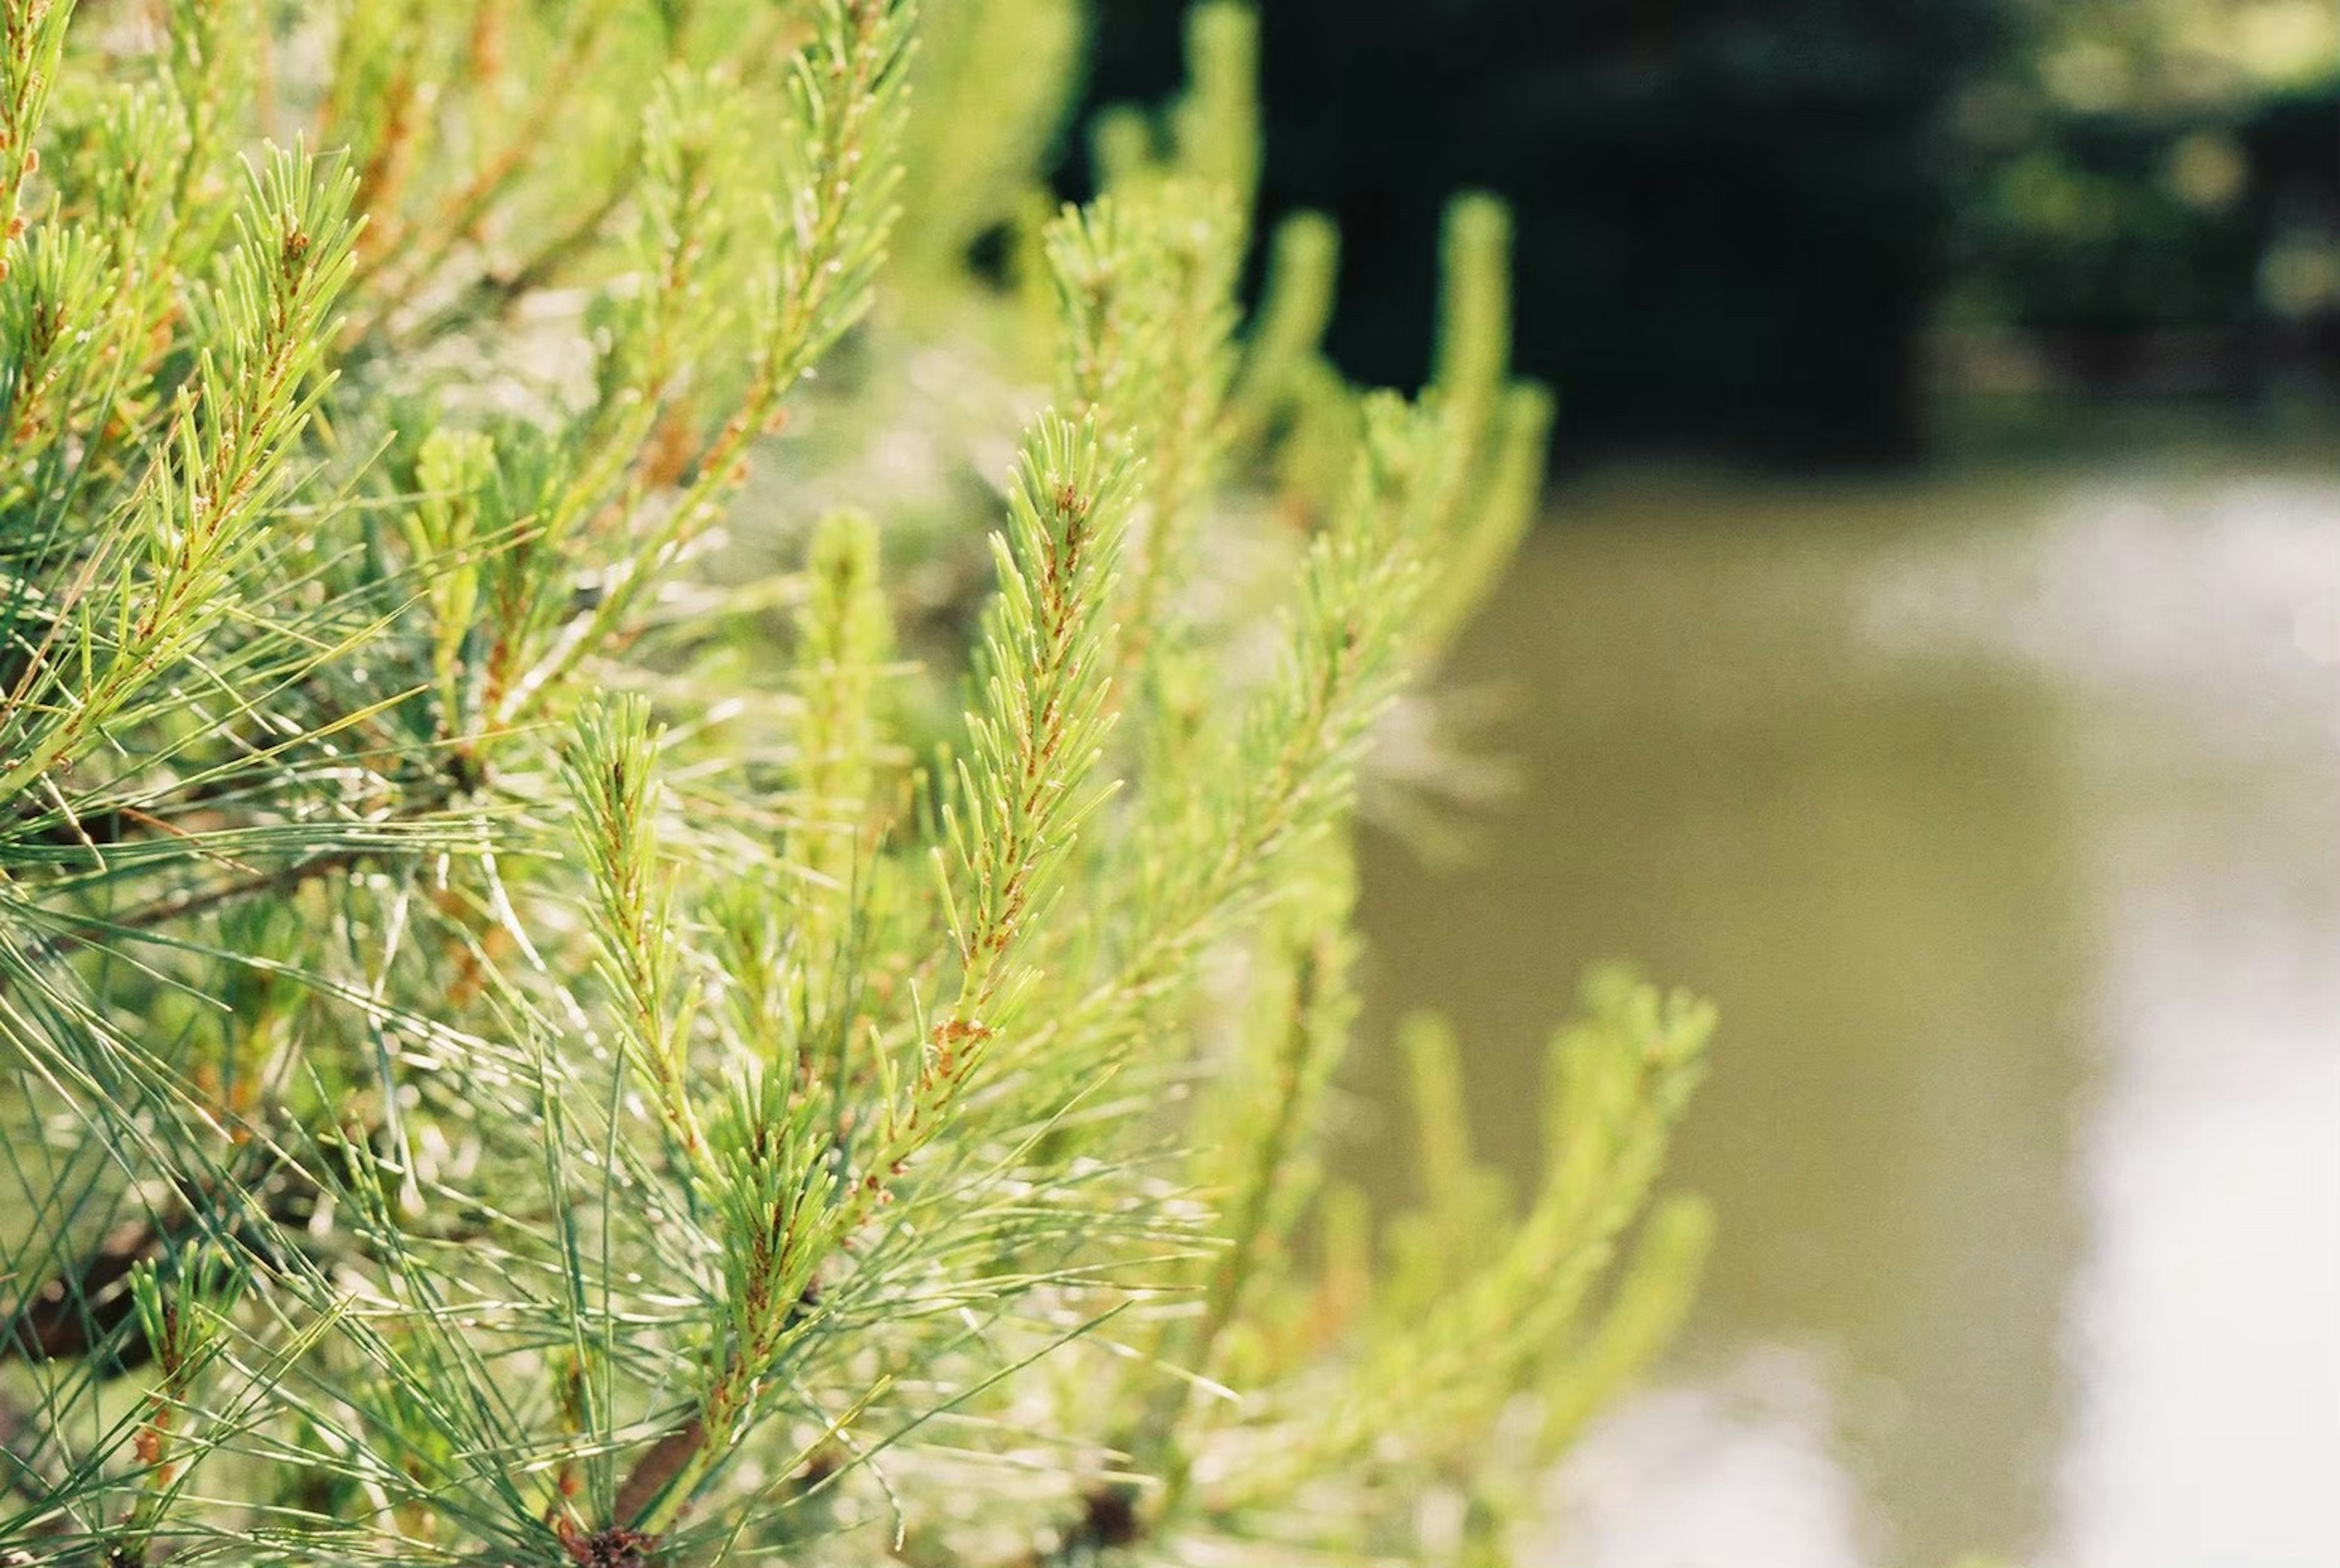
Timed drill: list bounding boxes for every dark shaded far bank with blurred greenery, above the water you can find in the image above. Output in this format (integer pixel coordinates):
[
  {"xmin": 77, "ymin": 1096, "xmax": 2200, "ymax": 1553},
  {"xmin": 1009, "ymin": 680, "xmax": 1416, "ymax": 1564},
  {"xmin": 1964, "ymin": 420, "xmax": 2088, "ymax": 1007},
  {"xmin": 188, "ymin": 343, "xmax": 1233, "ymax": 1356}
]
[{"xmin": 1062, "ymin": 0, "xmax": 2340, "ymax": 468}]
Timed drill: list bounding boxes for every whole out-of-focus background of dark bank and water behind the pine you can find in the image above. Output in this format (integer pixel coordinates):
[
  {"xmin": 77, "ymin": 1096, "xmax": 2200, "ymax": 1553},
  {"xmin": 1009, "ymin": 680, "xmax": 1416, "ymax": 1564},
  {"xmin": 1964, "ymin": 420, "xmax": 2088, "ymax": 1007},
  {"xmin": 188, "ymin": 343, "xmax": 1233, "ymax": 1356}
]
[{"xmin": 1060, "ymin": 0, "xmax": 2340, "ymax": 1568}]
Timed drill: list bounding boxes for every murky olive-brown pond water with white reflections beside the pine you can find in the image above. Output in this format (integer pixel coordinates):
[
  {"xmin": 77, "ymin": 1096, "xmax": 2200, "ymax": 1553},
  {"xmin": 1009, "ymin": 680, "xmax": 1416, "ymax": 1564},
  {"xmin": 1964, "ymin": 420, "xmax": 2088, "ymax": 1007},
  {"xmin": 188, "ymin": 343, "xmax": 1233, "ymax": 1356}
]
[{"xmin": 1357, "ymin": 452, "xmax": 2340, "ymax": 1568}]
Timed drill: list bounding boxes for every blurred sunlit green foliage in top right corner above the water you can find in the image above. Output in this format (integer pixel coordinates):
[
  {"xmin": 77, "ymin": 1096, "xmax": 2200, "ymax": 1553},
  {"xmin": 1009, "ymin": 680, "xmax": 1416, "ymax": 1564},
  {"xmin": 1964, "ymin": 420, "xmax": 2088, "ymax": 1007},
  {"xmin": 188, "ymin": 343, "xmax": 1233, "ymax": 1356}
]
[{"xmin": 1949, "ymin": 0, "xmax": 2340, "ymax": 363}]
